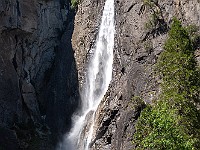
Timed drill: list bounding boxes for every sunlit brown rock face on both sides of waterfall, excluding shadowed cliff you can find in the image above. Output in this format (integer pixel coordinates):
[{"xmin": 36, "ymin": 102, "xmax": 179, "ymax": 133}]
[{"xmin": 72, "ymin": 0, "xmax": 200, "ymax": 150}]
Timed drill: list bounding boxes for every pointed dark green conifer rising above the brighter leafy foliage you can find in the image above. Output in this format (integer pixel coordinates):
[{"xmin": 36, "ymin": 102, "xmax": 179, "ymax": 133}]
[{"xmin": 157, "ymin": 19, "xmax": 200, "ymax": 100}]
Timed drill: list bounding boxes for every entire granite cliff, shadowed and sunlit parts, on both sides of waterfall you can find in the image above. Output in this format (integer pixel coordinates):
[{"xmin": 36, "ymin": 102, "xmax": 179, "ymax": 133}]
[{"xmin": 0, "ymin": 0, "xmax": 200, "ymax": 150}]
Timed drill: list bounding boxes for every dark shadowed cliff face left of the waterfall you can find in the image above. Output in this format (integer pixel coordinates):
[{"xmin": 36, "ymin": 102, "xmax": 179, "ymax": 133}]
[{"xmin": 0, "ymin": 0, "xmax": 79, "ymax": 150}]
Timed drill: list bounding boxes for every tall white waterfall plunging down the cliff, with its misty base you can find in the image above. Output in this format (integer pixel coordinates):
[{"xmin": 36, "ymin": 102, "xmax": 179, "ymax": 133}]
[{"xmin": 57, "ymin": 0, "xmax": 115, "ymax": 150}]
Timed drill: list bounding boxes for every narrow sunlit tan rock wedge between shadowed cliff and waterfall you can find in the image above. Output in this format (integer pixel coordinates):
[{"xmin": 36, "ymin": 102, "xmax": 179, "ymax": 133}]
[{"xmin": 72, "ymin": 0, "xmax": 105, "ymax": 87}]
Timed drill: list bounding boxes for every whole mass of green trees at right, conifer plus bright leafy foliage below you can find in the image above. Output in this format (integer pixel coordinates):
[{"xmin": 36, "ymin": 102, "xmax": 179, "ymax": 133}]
[{"xmin": 133, "ymin": 19, "xmax": 200, "ymax": 150}]
